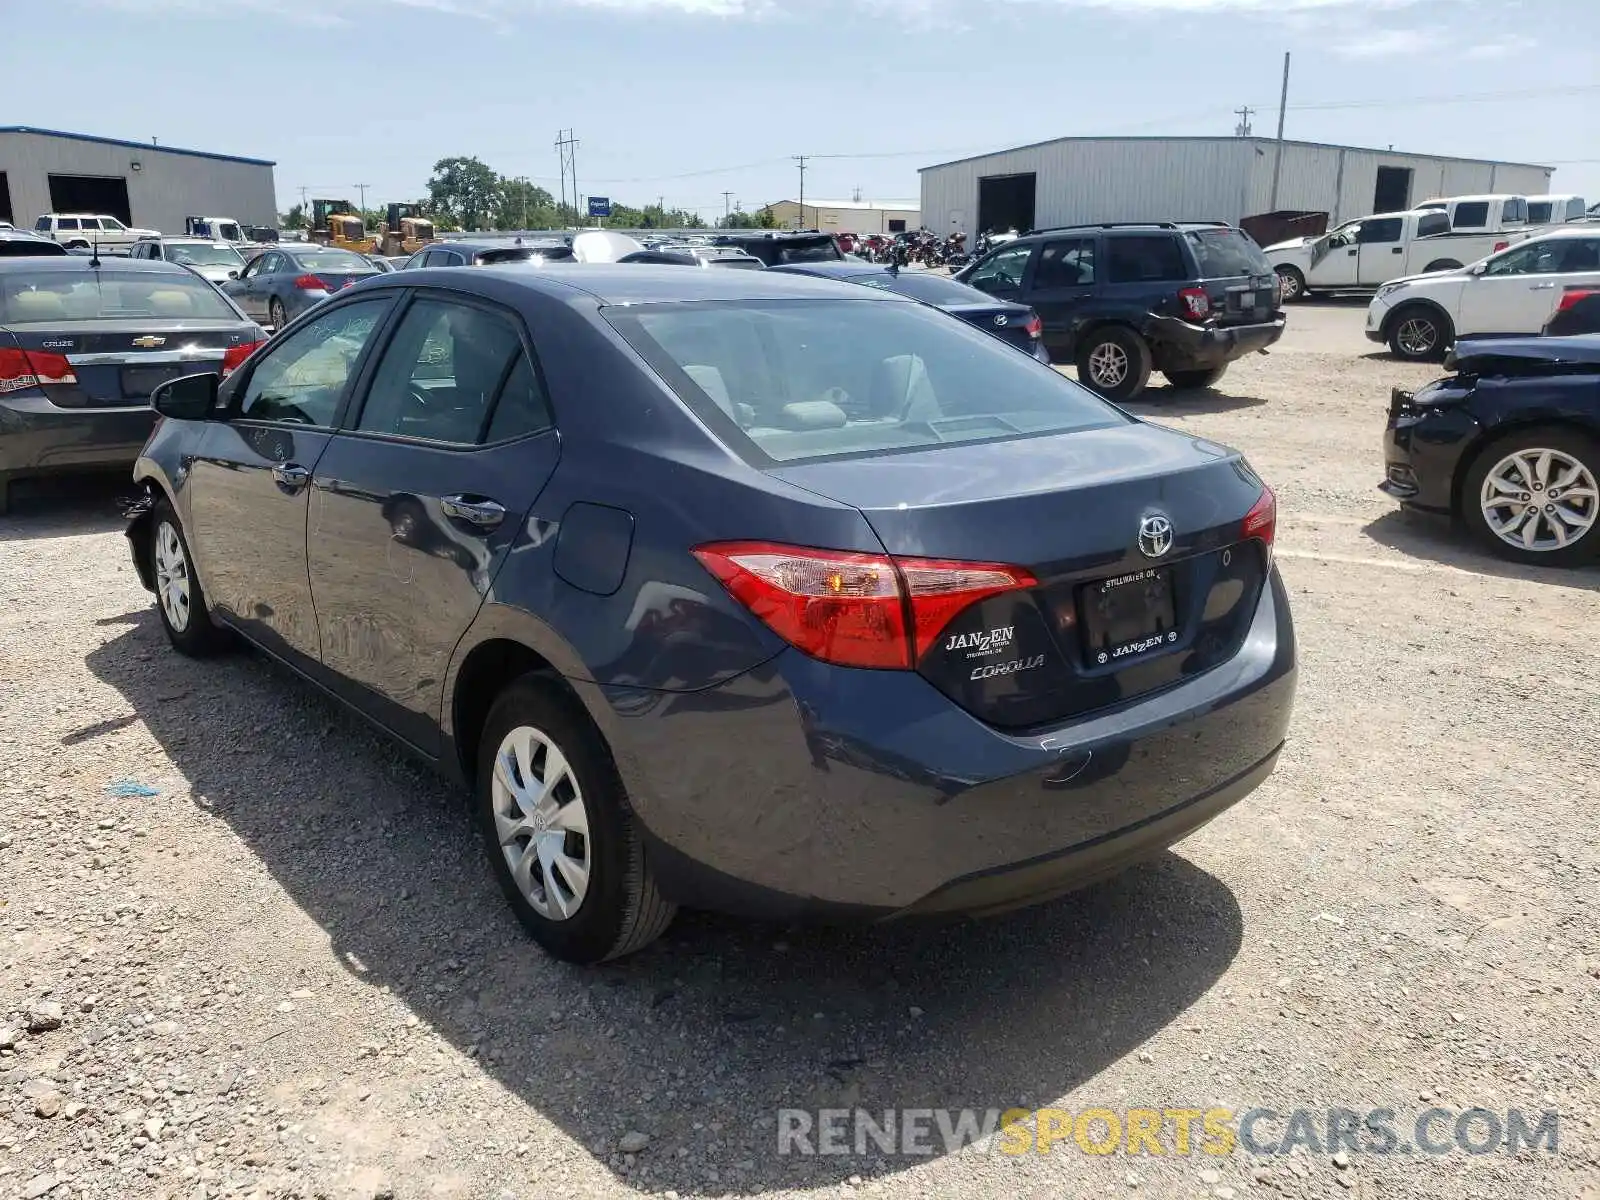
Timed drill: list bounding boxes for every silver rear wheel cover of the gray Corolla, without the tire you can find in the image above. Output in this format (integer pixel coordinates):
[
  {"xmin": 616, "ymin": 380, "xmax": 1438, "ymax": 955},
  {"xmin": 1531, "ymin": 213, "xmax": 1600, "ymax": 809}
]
[{"xmin": 491, "ymin": 725, "xmax": 590, "ymax": 922}]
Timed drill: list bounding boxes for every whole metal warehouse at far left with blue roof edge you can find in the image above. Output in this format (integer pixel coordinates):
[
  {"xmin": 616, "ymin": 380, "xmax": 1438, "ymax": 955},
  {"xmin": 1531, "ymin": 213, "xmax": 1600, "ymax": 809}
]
[{"xmin": 0, "ymin": 125, "xmax": 278, "ymax": 234}]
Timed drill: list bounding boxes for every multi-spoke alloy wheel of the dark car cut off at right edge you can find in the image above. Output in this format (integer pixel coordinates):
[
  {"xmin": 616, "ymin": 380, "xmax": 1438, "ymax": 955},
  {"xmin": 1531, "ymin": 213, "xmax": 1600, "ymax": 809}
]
[{"xmin": 1478, "ymin": 446, "xmax": 1600, "ymax": 552}]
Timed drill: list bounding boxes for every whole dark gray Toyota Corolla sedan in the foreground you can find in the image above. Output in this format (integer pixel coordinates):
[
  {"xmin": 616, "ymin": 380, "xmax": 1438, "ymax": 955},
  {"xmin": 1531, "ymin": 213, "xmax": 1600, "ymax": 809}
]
[{"xmin": 128, "ymin": 266, "xmax": 1296, "ymax": 962}]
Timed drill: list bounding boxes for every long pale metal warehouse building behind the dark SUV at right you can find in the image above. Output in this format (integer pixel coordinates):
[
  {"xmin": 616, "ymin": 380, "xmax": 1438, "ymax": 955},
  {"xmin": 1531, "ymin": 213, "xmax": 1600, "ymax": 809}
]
[{"xmin": 922, "ymin": 138, "xmax": 1555, "ymax": 241}]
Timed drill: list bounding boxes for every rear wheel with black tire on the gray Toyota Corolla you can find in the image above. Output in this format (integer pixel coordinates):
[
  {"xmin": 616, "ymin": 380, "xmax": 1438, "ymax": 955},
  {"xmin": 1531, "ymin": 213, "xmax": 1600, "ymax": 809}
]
[{"xmin": 474, "ymin": 674, "xmax": 677, "ymax": 965}]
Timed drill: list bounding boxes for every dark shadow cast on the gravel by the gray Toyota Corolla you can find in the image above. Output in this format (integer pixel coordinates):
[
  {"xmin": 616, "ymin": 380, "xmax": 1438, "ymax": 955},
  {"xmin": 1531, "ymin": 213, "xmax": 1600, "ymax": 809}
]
[{"xmin": 86, "ymin": 611, "xmax": 1242, "ymax": 1195}]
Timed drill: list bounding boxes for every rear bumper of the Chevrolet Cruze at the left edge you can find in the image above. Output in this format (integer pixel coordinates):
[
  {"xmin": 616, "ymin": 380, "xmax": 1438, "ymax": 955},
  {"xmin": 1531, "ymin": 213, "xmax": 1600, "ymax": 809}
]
[{"xmin": 0, "ymin": 389, "xmax": 155, "ymax": 478}]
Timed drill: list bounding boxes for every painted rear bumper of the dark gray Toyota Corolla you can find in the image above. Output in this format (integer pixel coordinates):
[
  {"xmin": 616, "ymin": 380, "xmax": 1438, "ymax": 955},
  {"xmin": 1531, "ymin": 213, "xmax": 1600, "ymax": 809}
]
[{"xmin": 603, "ymin": 571, "xmax": 1296, "ymax": 920}]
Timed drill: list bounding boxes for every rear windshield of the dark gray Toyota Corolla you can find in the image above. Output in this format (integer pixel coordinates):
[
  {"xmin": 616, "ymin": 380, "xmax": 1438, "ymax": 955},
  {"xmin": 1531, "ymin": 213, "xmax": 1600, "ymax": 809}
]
[{"xmin": 605, "ymin": 299, "xmax": 1128, "ymax": 466}]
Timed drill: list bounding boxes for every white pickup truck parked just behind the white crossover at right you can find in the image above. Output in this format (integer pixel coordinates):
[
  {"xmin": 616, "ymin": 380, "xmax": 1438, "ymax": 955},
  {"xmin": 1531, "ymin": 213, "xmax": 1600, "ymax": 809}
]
[{"xmin": 1267, "ymin": 210, "xmax": 1528, "ymax": 301}]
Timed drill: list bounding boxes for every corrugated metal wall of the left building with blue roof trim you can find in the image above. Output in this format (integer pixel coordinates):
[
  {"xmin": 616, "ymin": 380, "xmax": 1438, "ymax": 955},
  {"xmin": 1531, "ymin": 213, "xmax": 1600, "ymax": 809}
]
[{"xmin": 0, "ymin": 133, "xmax": 278, "ymax": 234}]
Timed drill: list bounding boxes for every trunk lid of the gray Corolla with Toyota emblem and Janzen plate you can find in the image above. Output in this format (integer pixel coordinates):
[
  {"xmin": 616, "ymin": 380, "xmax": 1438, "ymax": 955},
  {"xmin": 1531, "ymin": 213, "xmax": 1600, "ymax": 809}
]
[{"xmin": 771, "ymin": 424, "xmax": 1270, "ymax": 728}]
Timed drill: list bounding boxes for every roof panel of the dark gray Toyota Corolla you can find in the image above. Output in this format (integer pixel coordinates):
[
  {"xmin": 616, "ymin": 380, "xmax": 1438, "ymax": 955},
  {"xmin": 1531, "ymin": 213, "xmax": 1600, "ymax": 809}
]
[{"xmin": 406, "ymin": 262, "xmax": 915, "ymax": 304}]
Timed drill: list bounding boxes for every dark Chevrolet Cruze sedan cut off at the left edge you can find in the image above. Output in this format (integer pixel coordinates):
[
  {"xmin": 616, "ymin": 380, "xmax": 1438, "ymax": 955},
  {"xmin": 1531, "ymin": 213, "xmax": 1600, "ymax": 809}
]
[{"xmin": 0, "ymin": 254, "xmax": 266, "ymax": 512}]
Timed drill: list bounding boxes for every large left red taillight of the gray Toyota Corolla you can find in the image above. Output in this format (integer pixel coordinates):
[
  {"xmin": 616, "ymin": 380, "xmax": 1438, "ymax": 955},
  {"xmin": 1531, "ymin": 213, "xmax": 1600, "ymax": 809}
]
[{"xmin": 694, "ymin": 542, "xmax": 1037, "ymax": 670}]
